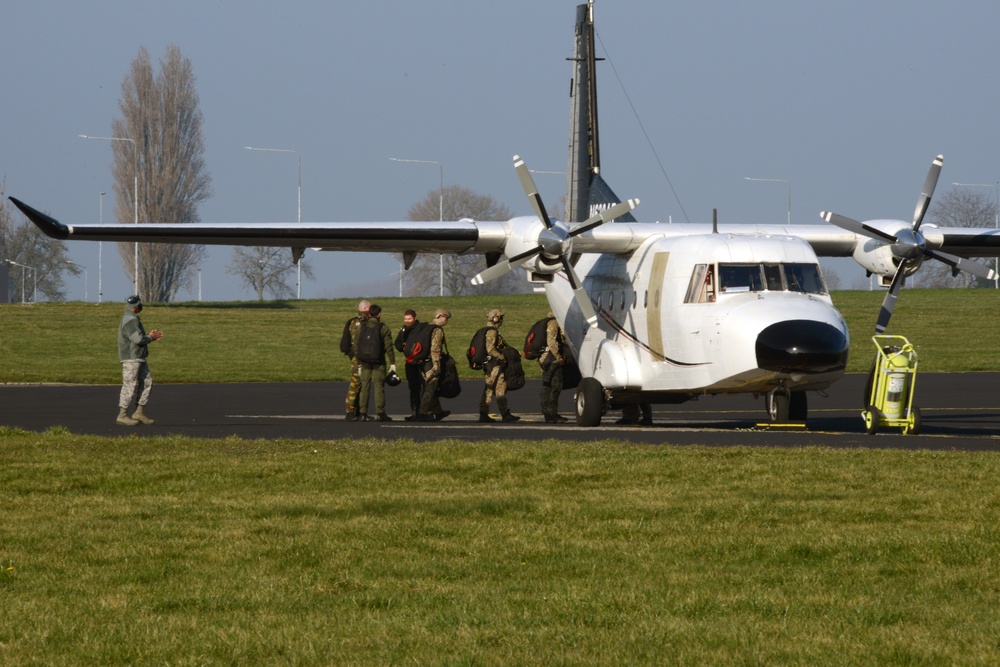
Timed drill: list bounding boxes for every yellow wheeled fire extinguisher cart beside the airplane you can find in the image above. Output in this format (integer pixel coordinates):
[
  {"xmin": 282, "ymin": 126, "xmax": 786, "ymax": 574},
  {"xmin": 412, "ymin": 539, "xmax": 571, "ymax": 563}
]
[{"xmin": 861, "ymin": 335, "xmax": 920, "ymax": 435}]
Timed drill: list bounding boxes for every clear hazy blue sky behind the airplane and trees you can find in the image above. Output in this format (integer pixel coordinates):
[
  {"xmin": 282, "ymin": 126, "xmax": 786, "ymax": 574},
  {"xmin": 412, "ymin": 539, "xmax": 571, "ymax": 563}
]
[{"xmin": 0, "ymin": 0, "xmax": 1000, "ymax": 301}]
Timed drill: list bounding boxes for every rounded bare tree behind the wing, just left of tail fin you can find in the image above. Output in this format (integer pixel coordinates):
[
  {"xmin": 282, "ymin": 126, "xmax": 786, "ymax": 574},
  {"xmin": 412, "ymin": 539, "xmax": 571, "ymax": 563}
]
[{"xmin": 404, "ymin": 185, "xmax": 530, "ymax": 296}]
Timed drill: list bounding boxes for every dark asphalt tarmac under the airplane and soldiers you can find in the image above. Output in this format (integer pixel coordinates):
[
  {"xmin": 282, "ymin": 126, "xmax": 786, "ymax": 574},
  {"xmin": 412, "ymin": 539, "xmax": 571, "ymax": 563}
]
[{"xmin": 0, "ymin": 374, "xmax": 1000, "ymax": 451}]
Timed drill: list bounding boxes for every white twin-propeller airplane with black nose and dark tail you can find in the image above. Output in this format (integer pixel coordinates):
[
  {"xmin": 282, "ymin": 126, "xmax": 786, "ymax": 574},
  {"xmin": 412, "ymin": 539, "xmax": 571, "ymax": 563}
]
[{"xmin": 10, "ymin": 0, "xmax": 1000, "ymax": 426}]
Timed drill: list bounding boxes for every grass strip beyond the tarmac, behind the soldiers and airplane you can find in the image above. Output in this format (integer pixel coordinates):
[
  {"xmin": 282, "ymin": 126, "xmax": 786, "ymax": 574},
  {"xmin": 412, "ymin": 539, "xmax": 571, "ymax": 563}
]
[{"xmin": 0, "ymin": 289, "xmax": 1000, "ymax": 384}]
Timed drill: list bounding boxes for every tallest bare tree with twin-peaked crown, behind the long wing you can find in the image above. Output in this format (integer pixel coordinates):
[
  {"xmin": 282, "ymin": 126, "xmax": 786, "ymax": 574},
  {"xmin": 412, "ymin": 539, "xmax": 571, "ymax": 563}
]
[{"xmin": 111, "ymin": 46, "xmax": 212, "ymax": 302}]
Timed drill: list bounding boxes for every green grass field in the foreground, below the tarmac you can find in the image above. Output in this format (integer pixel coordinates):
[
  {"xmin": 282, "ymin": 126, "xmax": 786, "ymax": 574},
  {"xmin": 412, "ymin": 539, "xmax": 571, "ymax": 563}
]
[{"xmin": 0, "ymin": 429, "xmax": 1000, "ymax": 665}]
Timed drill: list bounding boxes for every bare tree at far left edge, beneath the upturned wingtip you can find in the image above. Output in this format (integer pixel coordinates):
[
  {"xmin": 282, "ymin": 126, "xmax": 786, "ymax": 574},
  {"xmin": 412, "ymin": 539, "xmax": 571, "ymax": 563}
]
[{"xmin": 0, "ymin": 180, "xmax": 81, "ymax": 301}]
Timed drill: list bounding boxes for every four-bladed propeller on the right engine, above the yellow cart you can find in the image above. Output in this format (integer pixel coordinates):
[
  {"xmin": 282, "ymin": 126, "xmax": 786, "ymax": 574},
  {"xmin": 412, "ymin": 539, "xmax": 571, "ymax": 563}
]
[{"xmin": 820, "ymin": 155, "xmax": 996, "ymax": 334}]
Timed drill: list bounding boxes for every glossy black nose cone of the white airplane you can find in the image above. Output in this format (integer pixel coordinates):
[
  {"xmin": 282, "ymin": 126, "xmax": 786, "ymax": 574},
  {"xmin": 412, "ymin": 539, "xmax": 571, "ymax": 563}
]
[{"xmin": 757, "ymin": 320, "xmax": 848, "ymax": 373}]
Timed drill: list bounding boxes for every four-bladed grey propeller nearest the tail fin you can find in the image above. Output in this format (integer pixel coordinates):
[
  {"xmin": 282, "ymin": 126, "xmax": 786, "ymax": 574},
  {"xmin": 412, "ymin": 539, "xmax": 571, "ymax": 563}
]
[{"xmin": 472, "ymin": 155, "xmax": 639, "ymax": 327}]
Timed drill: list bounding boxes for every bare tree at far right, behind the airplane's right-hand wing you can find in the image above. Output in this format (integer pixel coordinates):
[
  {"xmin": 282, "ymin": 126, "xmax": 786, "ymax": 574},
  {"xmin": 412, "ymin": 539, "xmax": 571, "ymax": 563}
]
[{"xmin": 909, "ymin": 188, "xmax": 997, "ymax": 287}]
